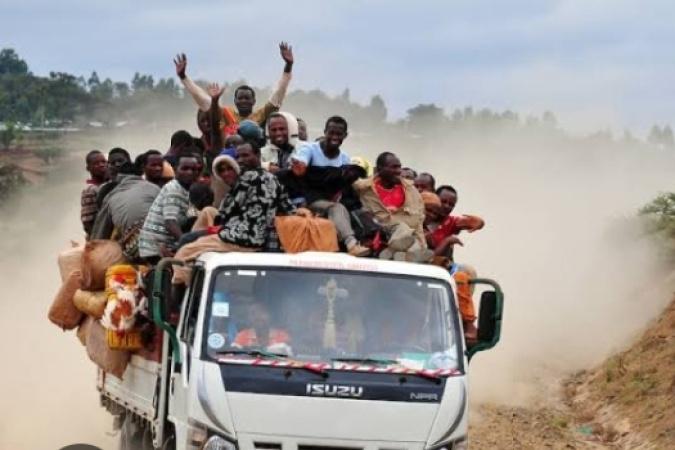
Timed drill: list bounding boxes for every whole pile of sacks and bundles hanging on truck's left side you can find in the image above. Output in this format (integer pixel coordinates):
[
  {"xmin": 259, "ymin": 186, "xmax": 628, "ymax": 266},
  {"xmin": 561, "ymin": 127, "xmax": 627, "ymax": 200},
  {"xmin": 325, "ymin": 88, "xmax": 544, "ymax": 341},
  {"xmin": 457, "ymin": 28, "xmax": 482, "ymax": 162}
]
[{"xmin": 48, "ymin": 240, "xmax": 152, "ymax": 378}]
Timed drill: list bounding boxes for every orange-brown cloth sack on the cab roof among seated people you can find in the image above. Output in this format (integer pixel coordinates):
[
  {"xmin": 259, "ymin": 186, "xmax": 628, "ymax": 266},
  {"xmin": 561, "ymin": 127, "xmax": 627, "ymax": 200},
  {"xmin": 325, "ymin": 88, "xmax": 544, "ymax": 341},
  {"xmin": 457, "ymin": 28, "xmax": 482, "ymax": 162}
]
[{"xmin": 274, "ymin": 216, "xmax": 339, "ymax": 253}]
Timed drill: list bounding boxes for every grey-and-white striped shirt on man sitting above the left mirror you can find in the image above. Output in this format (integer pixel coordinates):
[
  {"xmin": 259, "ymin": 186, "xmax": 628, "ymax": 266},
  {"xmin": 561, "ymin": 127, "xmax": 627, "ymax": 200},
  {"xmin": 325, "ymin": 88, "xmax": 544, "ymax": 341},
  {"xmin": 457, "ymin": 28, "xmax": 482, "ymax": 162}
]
[{"xmin": 139, "ymin": 180, "xmax": 190, "ymax": 258}]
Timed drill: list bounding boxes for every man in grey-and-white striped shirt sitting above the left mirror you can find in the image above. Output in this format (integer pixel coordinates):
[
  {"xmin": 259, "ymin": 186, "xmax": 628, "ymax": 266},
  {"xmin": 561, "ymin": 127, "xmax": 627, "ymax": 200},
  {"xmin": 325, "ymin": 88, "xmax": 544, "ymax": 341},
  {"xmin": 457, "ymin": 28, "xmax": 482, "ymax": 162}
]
[{"xmin": 139, "ymin": 151, "xmax": 199, "ymax": 264}]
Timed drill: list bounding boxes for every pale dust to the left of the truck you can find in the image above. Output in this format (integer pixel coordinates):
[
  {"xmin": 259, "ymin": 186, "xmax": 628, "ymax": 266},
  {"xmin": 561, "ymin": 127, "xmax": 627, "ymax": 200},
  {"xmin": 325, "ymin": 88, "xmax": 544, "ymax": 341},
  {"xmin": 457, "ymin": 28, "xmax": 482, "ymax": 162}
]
[{"xmin": 0, "ymin": 128, "xmax": 176, "ymax": 450}]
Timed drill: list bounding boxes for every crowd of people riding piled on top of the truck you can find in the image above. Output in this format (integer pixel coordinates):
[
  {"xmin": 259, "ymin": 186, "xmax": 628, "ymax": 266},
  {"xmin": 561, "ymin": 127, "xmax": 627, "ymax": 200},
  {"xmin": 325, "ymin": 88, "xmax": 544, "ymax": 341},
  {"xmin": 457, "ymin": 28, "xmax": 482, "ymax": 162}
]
[{"xmin": 81, "ymin": 43, "xmax": 484, "ymax": 338}]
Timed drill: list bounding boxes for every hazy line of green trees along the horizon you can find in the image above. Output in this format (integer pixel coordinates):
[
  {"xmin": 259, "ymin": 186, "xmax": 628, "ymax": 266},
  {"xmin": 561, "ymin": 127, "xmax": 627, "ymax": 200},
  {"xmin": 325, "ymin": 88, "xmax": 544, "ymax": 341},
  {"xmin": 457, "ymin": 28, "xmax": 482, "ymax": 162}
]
[{"xmin": 0, "ymin": 48, "xmax": 675, "ymax": 149}]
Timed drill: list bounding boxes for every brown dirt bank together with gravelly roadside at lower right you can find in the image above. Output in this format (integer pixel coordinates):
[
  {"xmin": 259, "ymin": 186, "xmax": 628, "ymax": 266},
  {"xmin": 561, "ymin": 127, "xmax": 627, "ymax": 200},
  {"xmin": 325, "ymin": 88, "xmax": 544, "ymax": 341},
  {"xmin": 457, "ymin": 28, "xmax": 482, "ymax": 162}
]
[{"xmin": 469, "ymin": 300, "xmax": 675, "ymax": 450}]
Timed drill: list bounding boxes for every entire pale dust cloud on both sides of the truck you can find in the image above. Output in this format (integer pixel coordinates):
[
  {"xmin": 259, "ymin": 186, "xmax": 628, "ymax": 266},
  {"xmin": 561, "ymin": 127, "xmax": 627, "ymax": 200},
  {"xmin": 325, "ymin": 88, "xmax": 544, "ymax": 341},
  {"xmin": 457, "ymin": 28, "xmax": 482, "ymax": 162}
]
[{"xmin": 0, "ymin": 112, "xmax": 675, "ymax": 450}]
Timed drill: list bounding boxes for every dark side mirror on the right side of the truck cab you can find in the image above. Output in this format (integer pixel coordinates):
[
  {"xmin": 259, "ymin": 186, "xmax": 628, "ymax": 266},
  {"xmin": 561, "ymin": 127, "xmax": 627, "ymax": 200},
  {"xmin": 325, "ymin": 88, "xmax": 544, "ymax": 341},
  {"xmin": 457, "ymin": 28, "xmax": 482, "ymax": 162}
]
[{"xmin": 466, "ymin": 278, "xmax": 504, "ymax": 360}]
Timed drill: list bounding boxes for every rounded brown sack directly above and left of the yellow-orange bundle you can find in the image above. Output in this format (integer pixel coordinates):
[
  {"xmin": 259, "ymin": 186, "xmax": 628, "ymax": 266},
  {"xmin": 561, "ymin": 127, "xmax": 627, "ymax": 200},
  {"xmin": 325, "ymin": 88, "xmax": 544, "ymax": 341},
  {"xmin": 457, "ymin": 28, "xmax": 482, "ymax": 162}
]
[{"xmin": 80, "ymin": 240, "xmax": 124, "ymax": 291}]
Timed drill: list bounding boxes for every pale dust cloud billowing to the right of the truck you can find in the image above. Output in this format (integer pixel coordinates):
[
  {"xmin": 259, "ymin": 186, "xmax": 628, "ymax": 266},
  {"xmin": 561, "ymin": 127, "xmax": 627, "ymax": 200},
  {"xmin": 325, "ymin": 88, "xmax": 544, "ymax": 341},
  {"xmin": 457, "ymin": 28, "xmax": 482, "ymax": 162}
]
[{"xmin": 400, "ymin": 133, "xmax": 675, "ymax": 404}]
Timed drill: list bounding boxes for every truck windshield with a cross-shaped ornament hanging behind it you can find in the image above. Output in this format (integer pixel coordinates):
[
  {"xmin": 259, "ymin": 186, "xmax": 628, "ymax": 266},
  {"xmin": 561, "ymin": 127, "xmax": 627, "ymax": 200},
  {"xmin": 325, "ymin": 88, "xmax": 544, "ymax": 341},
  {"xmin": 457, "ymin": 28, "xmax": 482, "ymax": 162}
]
[{"xmin": 205, "ymin": 268, "xmax": 459, "ymax": 370}]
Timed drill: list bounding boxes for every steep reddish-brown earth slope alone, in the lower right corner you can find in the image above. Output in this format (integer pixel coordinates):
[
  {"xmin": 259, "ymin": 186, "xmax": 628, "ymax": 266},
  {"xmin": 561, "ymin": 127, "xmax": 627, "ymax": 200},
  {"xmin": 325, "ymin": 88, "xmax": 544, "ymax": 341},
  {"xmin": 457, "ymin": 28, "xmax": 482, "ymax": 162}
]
[{"xmin": 568, "ymin": 301, "xmax": 675, "ymax": 449}]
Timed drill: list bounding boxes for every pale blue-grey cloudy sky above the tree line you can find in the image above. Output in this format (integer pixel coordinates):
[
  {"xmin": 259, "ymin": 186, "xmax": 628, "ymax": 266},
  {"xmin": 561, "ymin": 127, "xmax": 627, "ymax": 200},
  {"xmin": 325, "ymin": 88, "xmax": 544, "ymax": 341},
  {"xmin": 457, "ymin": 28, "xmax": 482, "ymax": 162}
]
[{"xmin": 0, "ymin": 0, "xmax": 675, "ymax": 134}]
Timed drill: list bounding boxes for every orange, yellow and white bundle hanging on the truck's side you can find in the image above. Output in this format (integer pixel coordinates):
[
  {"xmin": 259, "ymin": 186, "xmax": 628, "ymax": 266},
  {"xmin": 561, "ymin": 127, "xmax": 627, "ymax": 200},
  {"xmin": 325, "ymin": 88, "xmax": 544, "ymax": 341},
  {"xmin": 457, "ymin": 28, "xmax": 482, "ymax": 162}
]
[{"xmin": 101, "ymin": 264, "xmax": 147, "ymax": 350}]
